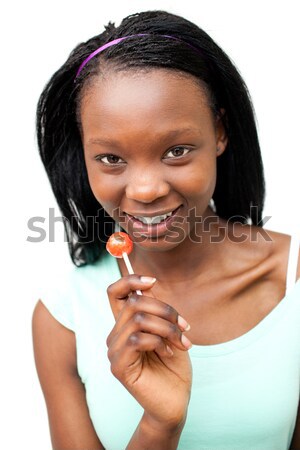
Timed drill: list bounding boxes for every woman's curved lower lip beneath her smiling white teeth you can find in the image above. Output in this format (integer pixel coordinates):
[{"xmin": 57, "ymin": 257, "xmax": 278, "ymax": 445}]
[{"xmin": 125, "ymin": 206, "xmax": 180, "ymax": 237}]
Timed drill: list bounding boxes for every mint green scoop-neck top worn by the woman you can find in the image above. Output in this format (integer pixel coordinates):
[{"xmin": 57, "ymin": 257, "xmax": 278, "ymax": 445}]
[{"xmin": 41, "ymin": 234, "xmax": 300, "ymax": 450}]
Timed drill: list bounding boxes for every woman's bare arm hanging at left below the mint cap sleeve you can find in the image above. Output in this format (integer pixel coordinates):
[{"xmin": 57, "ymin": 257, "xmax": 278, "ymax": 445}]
[{"xmin": 32, "ymin": 301, "xmax": 104, "ymax": 450}]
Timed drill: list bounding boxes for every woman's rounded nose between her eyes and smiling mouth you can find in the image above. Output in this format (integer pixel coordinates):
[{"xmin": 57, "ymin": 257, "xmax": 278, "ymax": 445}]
[{"xmin": 126, "ymin": 171, "xmax": 170, "ymax": 203}]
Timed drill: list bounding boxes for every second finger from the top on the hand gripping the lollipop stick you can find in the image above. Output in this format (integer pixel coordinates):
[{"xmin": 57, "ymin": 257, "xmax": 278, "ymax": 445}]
[{"xmin": 106, "ymin": 294, "xmax": 186, "ymax": 346}]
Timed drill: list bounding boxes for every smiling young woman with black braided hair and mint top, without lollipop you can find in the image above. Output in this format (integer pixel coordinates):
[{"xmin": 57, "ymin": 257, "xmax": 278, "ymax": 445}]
[{"xmin": 33, "ymin": 11, "xmax": 300, "ymax": 450}]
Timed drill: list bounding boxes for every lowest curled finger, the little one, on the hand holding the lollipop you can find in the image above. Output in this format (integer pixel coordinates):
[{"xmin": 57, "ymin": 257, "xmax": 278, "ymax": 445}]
[{"xmin": 108, "ymin": 332, "xmax": 172, "ymax": 379}]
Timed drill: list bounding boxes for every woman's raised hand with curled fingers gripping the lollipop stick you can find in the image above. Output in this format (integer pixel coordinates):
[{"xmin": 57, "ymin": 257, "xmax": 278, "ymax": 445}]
[{"xmin": 106, "ymin": 275, "xmax": 192, "ymax": 428}]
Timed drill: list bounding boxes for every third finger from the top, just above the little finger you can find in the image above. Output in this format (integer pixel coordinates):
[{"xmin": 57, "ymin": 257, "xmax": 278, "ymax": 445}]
[{"xmin": 110, "ymin": 311, "xmax": 191, "ymax": 352}]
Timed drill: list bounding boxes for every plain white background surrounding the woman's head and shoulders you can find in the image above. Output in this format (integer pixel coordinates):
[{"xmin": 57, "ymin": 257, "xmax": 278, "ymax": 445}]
[{"xmin": 0, "ymin": 0, "xmax": 300, "ymax": 450}]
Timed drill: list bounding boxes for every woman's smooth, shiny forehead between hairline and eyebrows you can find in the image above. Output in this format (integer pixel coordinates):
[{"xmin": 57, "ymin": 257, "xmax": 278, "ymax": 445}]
[{"xmin": 80, "ymin": 70, "xmax": 211, "ymax": 134}]
